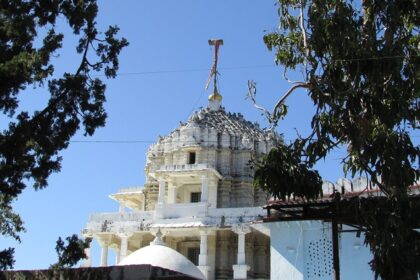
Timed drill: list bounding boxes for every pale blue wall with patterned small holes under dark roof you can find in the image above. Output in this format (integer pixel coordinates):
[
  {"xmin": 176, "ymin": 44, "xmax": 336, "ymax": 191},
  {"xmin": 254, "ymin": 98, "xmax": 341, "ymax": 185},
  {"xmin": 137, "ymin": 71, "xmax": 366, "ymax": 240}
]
[{"xmin": 264, "ymin": 221, "xmax": 373, "ymax": 280}]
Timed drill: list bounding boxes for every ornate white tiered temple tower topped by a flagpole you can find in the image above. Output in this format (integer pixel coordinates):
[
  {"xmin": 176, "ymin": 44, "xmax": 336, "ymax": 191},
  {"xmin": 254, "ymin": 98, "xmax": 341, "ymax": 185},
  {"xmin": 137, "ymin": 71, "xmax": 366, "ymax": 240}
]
[{"xmin": 83, "ymin": 40, "xmax": 279, "ymax": 279}]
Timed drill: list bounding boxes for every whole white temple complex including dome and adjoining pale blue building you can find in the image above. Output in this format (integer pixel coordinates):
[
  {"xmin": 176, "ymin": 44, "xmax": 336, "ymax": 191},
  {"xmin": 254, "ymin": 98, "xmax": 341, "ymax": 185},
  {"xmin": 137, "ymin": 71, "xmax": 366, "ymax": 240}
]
[{"xmin": 82, "ymin": 40, "xmax": 388, "ymax": 280}]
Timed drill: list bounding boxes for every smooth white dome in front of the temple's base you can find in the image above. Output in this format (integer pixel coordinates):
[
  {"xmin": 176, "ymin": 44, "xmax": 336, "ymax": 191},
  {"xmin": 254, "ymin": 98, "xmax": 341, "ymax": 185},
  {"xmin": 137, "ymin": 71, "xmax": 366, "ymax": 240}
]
[{"xmin": 118, "ymin": 244, "xmax": 205, "ymax": 279}]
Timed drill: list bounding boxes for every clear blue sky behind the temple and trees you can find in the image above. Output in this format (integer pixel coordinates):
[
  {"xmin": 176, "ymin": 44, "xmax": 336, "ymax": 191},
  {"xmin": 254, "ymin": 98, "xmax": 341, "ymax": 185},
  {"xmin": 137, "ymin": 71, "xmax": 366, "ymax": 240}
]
[{"xmin": 0, "ymin": 0, "xmax": 352, "ymax": 269}]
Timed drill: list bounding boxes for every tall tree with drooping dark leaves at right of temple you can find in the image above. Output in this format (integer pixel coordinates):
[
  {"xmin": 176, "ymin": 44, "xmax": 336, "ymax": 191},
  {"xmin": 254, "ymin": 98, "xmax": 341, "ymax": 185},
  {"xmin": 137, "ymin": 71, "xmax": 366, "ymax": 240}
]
[{"xmin": 249, "ymin": 0, "xmax": 420, "ymax": 279}]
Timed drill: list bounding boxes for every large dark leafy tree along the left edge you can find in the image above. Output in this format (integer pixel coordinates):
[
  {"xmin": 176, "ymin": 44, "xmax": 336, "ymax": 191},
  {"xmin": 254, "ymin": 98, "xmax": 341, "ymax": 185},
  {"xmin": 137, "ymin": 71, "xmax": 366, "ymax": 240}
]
[{"xmin": 0, "ymin": 0, "xmax": 128, "ymax": 267}]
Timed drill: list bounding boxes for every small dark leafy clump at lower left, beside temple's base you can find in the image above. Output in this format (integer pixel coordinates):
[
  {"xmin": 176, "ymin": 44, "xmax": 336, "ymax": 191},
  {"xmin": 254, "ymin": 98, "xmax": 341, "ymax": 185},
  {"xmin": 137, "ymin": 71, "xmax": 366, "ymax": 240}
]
[{"xmin": 51, "ymin": 234, "xmax": 92, "ymax": 269}]
